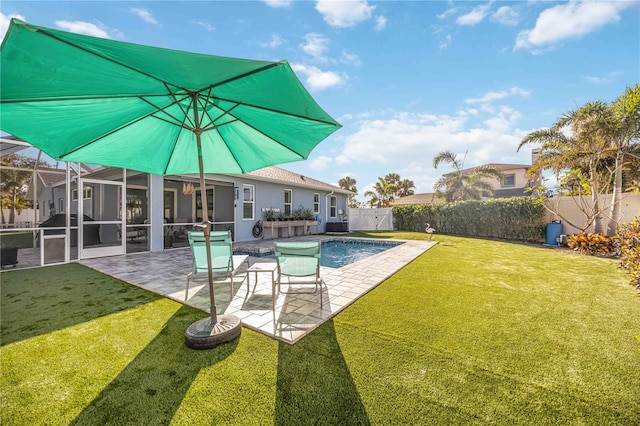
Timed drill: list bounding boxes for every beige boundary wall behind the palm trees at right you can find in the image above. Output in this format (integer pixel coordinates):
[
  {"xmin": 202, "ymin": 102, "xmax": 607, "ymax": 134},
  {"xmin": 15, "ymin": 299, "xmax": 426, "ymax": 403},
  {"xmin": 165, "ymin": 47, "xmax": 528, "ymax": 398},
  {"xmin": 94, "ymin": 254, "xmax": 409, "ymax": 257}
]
[{"xmin": 546, "ymin": 192, "xmax": 640, "ymax": 235}]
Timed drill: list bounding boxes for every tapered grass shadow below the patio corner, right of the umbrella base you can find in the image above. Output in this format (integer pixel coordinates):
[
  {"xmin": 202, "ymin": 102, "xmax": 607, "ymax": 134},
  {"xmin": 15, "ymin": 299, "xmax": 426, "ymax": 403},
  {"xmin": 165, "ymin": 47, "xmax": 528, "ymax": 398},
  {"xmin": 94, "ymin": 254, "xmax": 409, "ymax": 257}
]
[{"xmin": 274, "ymin": 320, "xmax": 370, "ymax": 425}]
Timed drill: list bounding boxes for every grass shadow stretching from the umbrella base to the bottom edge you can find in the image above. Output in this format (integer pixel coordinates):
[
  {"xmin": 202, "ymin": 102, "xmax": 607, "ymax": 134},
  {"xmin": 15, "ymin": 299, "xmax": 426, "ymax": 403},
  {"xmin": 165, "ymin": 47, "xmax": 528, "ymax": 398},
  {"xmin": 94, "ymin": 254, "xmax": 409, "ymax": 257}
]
[{"xmin": 71, "ymin": 306, "xmax": 239, "ymax": 425}]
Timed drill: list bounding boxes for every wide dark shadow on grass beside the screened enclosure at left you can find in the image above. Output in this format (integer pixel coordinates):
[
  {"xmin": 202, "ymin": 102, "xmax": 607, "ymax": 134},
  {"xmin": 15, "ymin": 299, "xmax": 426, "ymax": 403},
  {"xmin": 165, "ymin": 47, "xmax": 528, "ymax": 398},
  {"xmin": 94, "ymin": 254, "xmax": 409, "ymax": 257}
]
[{"xmin": 0, "ymin": 263, "xmax": 161, "ymax": 346}]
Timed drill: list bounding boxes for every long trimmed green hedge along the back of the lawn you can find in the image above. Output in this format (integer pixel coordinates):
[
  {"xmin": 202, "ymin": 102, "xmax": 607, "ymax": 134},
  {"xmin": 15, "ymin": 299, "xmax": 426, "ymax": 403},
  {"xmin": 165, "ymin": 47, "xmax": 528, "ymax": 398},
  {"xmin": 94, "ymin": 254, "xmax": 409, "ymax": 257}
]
[{"xmin": 393, "ymin": 197, "xmax": 545, "ymax": 242}]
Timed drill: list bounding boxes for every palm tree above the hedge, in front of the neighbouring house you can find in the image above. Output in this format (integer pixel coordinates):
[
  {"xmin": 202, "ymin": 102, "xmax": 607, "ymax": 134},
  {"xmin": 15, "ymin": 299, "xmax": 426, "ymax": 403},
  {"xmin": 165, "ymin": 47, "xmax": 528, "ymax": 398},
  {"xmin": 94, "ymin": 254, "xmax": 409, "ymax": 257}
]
[{"xmin": 433, "ymin": 151, "xmax": 502, "ymax": 202}]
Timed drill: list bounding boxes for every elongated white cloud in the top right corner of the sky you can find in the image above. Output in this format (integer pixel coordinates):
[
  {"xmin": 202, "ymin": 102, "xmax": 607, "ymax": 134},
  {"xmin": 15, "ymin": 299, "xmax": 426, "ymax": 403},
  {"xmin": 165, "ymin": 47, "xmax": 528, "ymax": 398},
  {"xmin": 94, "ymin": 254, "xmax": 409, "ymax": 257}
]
[{"xmin": 514, "ymin": 1, "xmax": 637, "ymax": 49}]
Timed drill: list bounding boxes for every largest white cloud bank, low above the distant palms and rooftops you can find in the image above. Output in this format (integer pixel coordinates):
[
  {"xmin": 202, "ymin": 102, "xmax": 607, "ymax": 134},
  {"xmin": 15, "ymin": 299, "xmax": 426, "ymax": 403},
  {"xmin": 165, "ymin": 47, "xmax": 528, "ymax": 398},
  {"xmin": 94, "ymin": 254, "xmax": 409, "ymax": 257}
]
[{"xmin": 335, "ymin": 106, "xmax": 530, "ymax": 195}]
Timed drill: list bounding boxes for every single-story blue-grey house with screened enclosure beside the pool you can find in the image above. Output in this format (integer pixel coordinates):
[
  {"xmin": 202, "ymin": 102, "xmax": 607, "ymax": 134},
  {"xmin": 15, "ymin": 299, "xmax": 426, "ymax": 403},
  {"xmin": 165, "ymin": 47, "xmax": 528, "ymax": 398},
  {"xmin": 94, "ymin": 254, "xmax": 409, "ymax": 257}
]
[{"xmin": 30, "ymin": 165, "xmax": 352, "ymax": 258}]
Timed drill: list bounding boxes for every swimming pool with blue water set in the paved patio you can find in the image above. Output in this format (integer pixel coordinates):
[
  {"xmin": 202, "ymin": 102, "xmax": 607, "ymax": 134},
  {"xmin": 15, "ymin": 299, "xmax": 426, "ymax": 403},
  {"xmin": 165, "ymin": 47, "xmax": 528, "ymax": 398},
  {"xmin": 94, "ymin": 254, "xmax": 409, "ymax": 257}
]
[{"xmin": 236, "ymin": 239, "xmax": 402, "ymax": 268}]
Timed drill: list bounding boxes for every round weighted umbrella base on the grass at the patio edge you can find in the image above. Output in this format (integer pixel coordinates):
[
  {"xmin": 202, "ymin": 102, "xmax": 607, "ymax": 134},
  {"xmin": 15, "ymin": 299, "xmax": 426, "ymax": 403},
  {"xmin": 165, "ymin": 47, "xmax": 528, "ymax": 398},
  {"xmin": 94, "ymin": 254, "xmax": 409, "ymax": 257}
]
[{"xmin": 184, "ymin": 315, "xmax": 242, "ymax": 349}]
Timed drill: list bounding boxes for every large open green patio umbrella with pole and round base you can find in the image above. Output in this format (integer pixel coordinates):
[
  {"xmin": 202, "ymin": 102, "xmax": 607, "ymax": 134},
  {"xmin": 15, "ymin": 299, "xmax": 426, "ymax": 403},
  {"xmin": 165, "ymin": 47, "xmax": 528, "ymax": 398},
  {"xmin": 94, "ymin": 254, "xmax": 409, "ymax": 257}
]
[{"xmin": 0, "ymin": 19, "xmax": 340, "ymax": 347}]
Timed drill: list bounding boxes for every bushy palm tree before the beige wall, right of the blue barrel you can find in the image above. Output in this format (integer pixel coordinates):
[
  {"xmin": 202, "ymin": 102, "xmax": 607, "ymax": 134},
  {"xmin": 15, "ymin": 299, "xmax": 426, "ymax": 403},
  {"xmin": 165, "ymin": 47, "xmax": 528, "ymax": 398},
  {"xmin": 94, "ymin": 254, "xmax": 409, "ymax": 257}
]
[{"xmin": 518, "ymin": 101, "xmax": 611, "ymax": 233}]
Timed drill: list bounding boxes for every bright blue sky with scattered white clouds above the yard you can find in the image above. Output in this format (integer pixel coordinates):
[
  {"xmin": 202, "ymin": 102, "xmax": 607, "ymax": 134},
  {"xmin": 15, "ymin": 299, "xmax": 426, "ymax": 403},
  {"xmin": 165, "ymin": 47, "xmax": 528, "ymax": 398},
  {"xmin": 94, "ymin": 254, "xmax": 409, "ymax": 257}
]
[{"xmin": 0, "ymin": 0, "xmax": 640, "ymax": 200}]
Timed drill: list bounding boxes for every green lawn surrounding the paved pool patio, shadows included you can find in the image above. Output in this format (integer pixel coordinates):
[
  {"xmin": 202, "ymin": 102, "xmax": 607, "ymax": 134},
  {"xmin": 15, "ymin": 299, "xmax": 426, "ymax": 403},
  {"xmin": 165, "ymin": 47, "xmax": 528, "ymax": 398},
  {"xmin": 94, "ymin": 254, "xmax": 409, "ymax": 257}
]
[{"xmin": 0, "ymin": 232, "xmax": 640, "ymax": 425}]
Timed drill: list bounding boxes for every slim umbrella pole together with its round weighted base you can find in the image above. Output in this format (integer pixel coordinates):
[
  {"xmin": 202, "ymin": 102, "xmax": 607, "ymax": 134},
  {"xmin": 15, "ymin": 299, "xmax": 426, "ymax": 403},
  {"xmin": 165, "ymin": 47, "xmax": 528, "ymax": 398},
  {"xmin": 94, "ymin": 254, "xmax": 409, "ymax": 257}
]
[{"xmin": 185, "ymin": 93, "xmax": 242, "ymax": 349}]
